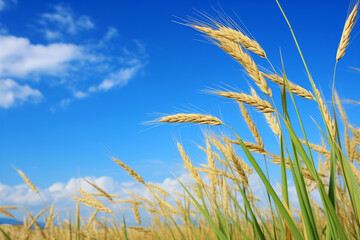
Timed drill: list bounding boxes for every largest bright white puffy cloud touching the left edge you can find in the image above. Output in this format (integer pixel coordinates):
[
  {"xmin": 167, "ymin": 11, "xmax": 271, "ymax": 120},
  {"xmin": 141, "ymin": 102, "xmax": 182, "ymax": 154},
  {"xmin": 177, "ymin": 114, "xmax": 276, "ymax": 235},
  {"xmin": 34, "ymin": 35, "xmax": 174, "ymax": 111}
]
[{"xmin": 0, "ymin": 36, "xmax": 83, "ymax": 77}]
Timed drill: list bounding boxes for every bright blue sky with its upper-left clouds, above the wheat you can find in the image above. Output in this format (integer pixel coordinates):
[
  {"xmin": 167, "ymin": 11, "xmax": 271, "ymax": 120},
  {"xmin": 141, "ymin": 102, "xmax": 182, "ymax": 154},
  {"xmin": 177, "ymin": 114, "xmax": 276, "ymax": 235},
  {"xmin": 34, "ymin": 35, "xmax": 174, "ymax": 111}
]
[{"xmin": 0, "ymin": 0, "xmax": 360, "ymax": 219}]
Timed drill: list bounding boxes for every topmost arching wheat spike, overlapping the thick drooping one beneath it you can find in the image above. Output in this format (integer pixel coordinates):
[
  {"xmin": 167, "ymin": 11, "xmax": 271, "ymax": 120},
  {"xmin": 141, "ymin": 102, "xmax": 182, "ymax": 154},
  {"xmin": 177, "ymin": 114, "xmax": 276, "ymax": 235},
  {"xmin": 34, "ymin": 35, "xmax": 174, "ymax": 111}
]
[{"xmin": 192, "ymin": 25, "xmax": 266, "ymax": 58}]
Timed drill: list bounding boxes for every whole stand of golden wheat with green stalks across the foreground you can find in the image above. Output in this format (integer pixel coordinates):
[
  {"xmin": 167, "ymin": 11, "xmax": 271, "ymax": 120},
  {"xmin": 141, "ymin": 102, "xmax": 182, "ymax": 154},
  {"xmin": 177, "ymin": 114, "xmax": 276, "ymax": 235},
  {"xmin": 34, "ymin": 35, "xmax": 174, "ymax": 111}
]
[{"xmin": 0, "ymin": 2, "xmax": 360, "ymax": 239}]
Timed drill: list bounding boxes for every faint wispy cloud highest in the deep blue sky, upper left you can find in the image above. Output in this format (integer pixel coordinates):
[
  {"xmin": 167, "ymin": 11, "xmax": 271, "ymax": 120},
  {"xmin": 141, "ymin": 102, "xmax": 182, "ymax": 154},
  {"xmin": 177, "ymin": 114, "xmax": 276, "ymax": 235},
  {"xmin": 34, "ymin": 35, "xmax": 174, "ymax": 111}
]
[{"xmin": 40, "ymin": 4, "xmax": 95, "ymax": 40}]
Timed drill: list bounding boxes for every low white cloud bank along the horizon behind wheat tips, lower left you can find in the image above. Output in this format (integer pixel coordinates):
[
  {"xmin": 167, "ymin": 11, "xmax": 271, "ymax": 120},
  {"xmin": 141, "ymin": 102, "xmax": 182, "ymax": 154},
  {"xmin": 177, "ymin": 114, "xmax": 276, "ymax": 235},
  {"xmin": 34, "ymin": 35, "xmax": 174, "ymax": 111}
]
[{"xmin": 0, "ymin": 175, "xmax": 192, "ymax": 221}]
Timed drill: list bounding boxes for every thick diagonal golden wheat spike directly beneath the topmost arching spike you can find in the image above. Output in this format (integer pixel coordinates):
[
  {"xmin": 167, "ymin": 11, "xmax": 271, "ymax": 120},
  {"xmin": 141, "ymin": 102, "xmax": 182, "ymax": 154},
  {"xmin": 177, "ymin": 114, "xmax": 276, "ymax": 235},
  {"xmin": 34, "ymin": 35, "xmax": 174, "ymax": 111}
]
[{"xmin": 217, "ymin": 38, "xmax": 272, "ymax": 96}]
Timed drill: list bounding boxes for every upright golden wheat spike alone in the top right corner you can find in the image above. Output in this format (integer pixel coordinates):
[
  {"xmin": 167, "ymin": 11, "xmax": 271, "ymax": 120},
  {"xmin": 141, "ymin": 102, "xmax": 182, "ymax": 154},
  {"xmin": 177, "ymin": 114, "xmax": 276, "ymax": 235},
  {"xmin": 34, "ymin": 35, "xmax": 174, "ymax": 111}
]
[{"xmin": 336, "ymin": 2, "xmax": 359, "ymax": 61}]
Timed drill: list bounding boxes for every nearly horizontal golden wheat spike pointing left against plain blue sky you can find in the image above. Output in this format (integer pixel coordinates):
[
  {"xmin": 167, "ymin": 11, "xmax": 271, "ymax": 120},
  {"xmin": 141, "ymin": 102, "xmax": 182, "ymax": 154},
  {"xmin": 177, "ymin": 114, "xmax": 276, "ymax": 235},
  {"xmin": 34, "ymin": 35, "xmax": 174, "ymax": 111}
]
[{"xmin": 159, "ymin": 113, "xmax": 223, "ymax": 125}]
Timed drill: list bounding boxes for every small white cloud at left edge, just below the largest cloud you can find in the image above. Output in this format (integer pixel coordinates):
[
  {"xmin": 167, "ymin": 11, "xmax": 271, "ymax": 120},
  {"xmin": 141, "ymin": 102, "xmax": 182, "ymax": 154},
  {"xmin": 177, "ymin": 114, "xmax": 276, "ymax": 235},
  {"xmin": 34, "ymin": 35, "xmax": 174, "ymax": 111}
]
[{"xmin": 0, "ymin": 79, "xmax": 42, "ymax": 109}]
